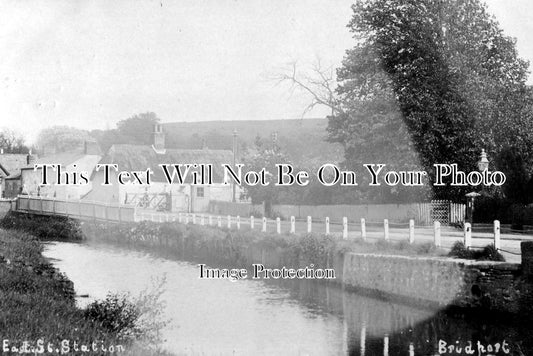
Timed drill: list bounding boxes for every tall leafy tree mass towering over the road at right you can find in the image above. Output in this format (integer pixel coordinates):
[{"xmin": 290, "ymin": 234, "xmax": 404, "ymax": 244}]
[{"xmin": 329, "ymin": 0, "xmax": 533, "ymax": 198}]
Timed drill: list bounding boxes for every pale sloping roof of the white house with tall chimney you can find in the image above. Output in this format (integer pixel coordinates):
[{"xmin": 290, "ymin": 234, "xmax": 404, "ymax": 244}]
[{"xmin": 100, "ymin": 144, "xmax": 233, "ymax": 182}]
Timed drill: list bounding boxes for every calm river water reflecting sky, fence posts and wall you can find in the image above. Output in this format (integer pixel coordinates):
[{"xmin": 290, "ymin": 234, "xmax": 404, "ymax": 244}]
[{"xmin": 45, "ymin": 242, "xmax": 533, "ymax": 356}]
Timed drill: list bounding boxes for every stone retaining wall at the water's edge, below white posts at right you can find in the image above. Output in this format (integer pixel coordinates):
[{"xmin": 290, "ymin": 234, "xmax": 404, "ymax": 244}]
[{"xmin": 343, "ymin": 253, "xmax": 522, "ymax": 312}]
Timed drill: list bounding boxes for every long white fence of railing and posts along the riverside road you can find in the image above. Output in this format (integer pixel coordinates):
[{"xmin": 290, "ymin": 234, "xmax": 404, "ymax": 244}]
[{"xmin": 15, "ymin": 195, "xmax": 490, "ymax": 252}]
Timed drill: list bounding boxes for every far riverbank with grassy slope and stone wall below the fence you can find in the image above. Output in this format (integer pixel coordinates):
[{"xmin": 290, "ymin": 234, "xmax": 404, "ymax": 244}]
[{"xmin": 6, "ymin": 214, "xmax": 533, "ymax": 315}]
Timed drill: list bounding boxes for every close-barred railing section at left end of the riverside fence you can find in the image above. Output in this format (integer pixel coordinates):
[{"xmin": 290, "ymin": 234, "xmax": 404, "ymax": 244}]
[{"xmin": 15, "ymin": 195, "xmax": 135, "ymax": 221}]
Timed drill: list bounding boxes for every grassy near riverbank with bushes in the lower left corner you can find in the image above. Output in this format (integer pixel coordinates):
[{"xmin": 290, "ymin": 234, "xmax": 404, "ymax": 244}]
[{"xmin": 0, "ymin": 229, "xmax": 170, "ymax": 355}]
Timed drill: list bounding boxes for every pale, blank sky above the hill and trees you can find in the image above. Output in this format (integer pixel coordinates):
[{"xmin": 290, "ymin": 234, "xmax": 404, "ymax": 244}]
[{"xmin": 0, "ymin": 0, "xmax": 533, "ymax": 143}]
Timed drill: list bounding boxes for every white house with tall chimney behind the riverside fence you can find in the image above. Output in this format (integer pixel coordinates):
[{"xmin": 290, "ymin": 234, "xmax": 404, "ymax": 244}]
[{"xmin": 86, "ymin": 124, "xmax": 233, "ymax": 212}]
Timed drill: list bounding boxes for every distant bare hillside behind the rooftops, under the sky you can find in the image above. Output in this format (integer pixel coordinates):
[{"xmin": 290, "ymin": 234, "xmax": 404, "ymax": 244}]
[{"xmin": 163, "ymin": 119, "xmax": 343, "ymax": 165}]
